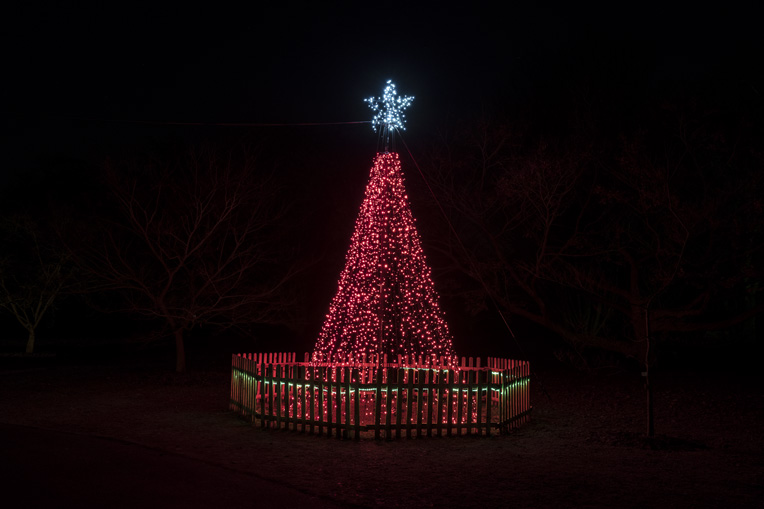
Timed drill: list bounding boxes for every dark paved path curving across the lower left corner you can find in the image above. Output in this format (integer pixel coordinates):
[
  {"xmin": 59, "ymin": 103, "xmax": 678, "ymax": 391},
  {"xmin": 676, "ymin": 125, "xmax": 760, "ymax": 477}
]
[{"xmin": 0, "ymin": 423, "xmax": 345, "ymax": 509}]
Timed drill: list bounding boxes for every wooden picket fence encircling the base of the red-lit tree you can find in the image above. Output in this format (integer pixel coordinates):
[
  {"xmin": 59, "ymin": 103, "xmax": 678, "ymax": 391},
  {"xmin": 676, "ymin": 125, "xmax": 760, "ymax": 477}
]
[{"xmin": 230, "ymin": 353, "xmax": 531, "ymax": 439}]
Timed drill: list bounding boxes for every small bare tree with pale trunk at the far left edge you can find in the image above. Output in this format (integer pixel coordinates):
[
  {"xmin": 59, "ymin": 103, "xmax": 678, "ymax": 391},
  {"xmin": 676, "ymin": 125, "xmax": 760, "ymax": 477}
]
[{"xmin": 0, "ymin": 215, "xmax": 73, "ymax": 354}]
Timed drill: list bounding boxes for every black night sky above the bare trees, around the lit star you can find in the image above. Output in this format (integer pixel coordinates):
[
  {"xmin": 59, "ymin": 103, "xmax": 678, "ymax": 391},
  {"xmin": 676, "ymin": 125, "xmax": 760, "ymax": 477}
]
[{"xmin": 0, "ymin": 2, "xmax": 764, "ymax": 354}]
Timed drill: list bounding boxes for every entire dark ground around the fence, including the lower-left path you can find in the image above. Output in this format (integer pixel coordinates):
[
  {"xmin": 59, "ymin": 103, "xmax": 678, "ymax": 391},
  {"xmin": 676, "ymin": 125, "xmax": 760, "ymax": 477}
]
[{"xmin": 0, "ymin": 350, "xmax": 764, "ymax": 508}]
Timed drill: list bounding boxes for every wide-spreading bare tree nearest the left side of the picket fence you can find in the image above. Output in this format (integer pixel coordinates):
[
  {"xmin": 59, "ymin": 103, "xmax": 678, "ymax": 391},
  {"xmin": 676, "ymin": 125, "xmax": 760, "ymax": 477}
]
[{"xmin": 79, "ymin": 146, "xmax": 295, "ymax": 372}]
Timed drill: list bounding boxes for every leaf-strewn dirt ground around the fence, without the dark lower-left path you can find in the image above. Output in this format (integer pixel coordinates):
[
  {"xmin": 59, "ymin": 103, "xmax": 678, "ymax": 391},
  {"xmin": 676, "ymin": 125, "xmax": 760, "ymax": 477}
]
[{"xmin": 0, "ymin": 366, "xmax": 764, "ymax": 507}]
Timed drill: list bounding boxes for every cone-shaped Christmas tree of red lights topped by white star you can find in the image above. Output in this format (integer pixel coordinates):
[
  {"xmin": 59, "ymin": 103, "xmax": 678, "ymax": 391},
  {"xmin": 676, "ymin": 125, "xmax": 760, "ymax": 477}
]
[{"xmin": 313, "ymin": 82, "xmax": 453, "ymax": 361}]
